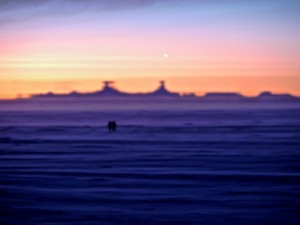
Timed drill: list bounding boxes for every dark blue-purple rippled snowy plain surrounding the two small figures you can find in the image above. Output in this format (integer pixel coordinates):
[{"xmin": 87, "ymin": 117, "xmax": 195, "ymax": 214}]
[{"xmin": 0, "ymin": 102, "xmax": 300, "ymax": 225}]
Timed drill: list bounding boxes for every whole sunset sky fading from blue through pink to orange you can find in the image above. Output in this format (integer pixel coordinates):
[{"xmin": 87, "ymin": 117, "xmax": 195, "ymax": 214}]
[{"xmin": 0, "ymin": 0, "xmax": 300, "ymax": 99}]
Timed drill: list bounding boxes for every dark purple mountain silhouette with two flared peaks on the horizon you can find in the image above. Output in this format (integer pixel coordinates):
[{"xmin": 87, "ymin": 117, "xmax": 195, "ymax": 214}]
[{"xmin": 31, "ymin": 81, "xmax": 300, "ymax": 101}]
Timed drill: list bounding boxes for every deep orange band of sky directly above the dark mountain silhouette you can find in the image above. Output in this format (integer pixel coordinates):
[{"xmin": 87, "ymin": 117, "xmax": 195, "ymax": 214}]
[{"xmin": 0, "ymin": 76, "xmax": 300, "ymax": 99}]
